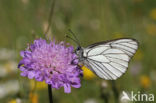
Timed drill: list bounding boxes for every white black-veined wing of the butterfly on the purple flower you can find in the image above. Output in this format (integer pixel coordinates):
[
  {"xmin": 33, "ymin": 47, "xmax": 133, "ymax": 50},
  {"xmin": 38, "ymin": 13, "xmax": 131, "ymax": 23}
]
[{"xmin": 83, "ymin": 38, "xmax": 138, "ymax": 80}]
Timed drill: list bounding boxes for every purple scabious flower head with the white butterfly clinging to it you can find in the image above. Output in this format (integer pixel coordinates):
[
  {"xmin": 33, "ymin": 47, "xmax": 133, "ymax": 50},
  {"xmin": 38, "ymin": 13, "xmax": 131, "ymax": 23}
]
[{"xmin": 18, "ymin": 39, "xmax": 82, "ymax": 93}]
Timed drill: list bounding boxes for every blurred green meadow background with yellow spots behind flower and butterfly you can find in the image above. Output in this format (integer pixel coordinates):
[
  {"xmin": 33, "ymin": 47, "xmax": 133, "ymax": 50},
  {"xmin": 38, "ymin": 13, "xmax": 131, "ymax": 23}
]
[{"xmin": 0, "ymin": 0, "xmax": 156, "ymax": 103}]
